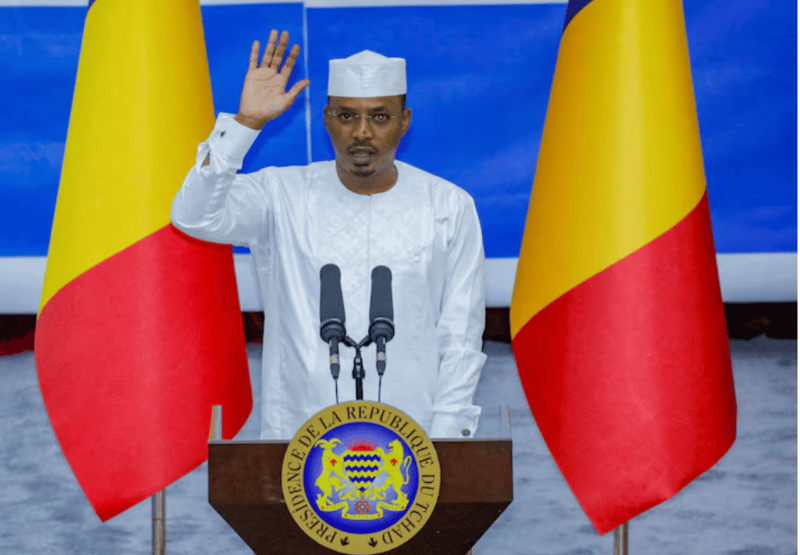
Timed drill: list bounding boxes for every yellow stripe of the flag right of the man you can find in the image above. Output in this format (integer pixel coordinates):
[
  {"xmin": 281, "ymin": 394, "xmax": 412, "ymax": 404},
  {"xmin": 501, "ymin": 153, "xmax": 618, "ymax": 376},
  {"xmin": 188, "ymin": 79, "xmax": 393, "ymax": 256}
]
[{"xmin": 511, "ymin": 0, "xmax": 705, "ymax": 336}]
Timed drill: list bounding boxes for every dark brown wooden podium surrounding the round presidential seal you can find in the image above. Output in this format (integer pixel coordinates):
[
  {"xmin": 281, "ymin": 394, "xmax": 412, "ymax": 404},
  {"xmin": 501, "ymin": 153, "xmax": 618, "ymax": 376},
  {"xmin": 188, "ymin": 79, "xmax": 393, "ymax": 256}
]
[{"xmin": 208, "ymin": 439, "xmax": 513, "ymax": 555}]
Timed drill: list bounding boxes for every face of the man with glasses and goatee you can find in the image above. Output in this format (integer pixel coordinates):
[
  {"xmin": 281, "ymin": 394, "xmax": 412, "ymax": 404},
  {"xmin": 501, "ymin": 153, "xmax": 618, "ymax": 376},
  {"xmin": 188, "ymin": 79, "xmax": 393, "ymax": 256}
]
[{"xmin": 325, "ymin": 96, "xmax": 411, "ymax": 177}]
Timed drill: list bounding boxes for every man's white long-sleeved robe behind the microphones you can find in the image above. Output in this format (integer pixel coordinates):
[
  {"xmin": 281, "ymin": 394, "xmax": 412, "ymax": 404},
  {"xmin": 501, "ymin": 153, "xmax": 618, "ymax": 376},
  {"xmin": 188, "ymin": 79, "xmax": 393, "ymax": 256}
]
[{"xmin": 171, "ymin": 114, "xmax": 486, "ymax": 439}]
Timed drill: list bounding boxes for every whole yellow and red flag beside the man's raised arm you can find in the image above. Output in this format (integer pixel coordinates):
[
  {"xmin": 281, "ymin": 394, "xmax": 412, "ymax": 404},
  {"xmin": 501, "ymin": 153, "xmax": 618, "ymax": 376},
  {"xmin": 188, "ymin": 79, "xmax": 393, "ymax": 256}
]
[{"xmin": 35, "ymin": 0, "xmax": 252, "ymax": 520}]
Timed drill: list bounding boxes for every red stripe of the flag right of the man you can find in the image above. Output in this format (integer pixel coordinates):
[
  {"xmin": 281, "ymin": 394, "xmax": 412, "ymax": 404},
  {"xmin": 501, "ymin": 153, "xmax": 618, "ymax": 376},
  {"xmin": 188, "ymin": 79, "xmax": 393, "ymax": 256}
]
[{"xmin": 513, "ymin": 195, "xmax": 736, "ymax": 534}]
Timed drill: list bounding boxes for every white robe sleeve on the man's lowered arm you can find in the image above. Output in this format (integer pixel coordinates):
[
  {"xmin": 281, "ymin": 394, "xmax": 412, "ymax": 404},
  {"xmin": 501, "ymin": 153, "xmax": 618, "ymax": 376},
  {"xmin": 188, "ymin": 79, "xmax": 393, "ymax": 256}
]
[{"xmin": 430, "ymin": 198, "xmax": 486, "ymax": 438}]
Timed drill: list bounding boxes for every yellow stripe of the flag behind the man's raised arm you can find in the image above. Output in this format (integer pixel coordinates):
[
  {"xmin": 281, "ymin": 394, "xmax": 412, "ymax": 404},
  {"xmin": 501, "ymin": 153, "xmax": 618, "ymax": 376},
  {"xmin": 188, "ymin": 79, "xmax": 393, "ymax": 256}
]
[{"xmin": 39, "ymin": 0, "xmax": 214, "ymax": 311}]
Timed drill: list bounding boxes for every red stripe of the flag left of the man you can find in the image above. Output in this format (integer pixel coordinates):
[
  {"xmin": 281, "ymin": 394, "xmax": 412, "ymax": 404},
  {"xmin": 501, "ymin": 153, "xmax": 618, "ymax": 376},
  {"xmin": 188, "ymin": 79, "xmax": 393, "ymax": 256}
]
[{"xmin": 35, "ymin": 225, "xmax": 252, "ymax": 521}]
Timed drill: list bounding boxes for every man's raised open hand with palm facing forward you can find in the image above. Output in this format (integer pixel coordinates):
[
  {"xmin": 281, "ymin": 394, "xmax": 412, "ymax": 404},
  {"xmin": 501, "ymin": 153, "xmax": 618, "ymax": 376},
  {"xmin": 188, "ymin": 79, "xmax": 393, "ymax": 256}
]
[{"xmin": 236, "ymin": 29, "xmax": 310, "ymax": 129}]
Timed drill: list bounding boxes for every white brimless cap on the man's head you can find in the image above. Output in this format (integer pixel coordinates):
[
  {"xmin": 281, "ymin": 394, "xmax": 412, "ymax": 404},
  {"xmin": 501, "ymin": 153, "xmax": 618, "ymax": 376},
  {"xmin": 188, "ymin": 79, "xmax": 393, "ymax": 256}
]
[{"xmin": 328, "ymin": 50, "xmax": 406, "ymax": 98}]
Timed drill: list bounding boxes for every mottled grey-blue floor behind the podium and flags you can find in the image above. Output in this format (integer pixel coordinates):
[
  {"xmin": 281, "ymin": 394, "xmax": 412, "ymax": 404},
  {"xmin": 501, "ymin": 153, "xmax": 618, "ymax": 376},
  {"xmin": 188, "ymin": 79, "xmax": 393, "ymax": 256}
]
[{"xmin": 0, "ymin": 336, "xmax": 797, "ymax": 555}]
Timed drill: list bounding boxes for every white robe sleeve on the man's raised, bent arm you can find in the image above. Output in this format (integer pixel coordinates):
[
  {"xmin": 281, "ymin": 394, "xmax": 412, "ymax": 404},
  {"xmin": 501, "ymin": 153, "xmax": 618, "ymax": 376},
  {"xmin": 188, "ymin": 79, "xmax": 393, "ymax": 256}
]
[{"xmin": 170, "ymin": 113, "xmax": 270, "ymax": 246}]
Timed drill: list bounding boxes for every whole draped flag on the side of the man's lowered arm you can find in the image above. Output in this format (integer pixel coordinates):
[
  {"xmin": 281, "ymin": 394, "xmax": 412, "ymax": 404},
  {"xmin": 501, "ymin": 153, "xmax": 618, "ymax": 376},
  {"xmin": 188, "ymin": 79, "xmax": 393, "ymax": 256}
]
[{"xmin": 511, "ymin": 0, "xmax": 736, "ymax": 534}]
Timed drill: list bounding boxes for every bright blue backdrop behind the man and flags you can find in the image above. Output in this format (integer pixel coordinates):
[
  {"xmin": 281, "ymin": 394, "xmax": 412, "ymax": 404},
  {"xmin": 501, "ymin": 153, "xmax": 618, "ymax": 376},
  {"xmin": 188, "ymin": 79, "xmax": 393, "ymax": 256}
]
[{"xmin": 0, "ymin": 0, "xmax": 797, "ymax": 257}]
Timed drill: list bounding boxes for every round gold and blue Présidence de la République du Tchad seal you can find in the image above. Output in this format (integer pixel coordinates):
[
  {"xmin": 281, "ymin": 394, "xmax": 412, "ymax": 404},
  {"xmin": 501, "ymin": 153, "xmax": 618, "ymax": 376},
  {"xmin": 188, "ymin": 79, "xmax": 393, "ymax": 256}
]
[{"xmin": 281, "ymin": 401, "xmax": 441, "ymax": 554}]
